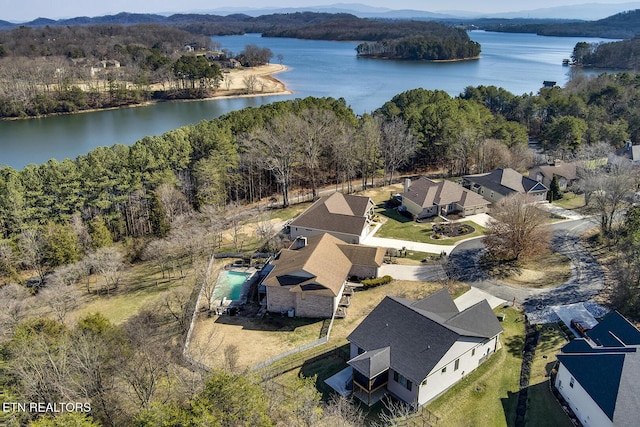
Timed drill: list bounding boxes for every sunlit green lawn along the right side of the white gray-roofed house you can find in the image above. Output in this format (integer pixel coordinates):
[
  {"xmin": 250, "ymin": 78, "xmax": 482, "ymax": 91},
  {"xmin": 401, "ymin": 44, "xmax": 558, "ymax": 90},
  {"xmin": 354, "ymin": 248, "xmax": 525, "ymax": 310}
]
[{"xmin": 418, "ymin": 308, "xmax": 524, "ymax": 427}]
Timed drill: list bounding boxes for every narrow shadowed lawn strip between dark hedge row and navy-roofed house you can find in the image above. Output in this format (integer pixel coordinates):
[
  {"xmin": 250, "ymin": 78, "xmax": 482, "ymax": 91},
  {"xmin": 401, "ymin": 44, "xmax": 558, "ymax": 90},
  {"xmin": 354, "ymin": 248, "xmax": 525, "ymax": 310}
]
[{"xmin": 526, "ymin": 324, "xmax": 573, "ymax": 427}]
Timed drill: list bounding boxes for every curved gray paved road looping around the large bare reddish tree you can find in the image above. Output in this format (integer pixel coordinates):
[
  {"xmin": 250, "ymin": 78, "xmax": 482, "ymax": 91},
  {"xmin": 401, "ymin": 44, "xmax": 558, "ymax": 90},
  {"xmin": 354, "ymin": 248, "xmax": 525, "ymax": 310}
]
[{"xmin": 446, "ymin": 219, "xmax": 604, "ymax": 312}]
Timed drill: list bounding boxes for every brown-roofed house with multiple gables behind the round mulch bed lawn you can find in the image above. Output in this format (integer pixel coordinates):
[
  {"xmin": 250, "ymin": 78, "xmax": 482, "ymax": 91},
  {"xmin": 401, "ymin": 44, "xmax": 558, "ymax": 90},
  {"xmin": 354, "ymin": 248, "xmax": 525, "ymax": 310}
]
[{"xmin": 401, "ymin": 177, "xmax": 490, "ymax": 219}]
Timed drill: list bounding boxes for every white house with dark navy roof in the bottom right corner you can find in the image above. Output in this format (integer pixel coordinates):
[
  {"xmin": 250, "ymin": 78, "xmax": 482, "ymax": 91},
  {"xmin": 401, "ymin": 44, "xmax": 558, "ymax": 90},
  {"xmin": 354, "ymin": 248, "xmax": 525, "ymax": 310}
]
[{"xmin": 555, "ymin": 312, "xmax": 640, "ymax": 427}]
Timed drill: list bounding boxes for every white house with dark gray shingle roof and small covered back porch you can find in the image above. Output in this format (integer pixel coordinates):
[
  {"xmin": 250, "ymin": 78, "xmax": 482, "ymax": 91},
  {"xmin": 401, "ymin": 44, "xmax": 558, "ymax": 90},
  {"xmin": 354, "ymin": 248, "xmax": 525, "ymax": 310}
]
[{"xmin": 347, "ymin": 289, "xmax": 502, "ymax": 406}]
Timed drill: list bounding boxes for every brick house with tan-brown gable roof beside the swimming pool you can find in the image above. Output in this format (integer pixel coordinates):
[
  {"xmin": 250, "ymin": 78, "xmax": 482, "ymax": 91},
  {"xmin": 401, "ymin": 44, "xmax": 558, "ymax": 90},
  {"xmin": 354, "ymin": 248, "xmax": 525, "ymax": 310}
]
[{"xmin": 262, "ymin": 233, "xmax": 385, "ymax": 318}]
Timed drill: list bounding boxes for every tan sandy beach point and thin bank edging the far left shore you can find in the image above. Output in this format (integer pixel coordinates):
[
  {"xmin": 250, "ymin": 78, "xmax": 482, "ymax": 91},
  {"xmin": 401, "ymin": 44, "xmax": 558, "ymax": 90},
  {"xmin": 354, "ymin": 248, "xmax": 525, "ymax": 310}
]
[{"xmin": 0, "ymin": 64, "xmax": 293, "ymax": 121}]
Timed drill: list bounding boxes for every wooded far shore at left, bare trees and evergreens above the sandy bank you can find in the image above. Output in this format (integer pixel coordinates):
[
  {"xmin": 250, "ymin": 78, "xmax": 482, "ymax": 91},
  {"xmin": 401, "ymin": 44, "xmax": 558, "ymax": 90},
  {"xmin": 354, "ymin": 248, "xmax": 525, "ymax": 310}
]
[{"xmin": 0, "ymin": 24, "xmax": 273, "ymax": 118}]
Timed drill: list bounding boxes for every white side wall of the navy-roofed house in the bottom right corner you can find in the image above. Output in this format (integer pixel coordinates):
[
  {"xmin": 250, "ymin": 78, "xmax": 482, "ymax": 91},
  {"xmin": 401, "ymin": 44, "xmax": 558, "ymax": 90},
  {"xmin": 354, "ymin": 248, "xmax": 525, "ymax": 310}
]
[{"xmin": 556, "ymin": 363, "xmax": 613, "ymax": 427}]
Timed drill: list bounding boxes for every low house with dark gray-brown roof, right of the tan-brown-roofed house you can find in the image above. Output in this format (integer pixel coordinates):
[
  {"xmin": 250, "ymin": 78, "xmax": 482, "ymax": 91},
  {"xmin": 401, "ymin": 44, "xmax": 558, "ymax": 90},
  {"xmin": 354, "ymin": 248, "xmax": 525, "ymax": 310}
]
[{"xmin": 462, "ymin": 168, "xmax": 549, "ymax": 203}]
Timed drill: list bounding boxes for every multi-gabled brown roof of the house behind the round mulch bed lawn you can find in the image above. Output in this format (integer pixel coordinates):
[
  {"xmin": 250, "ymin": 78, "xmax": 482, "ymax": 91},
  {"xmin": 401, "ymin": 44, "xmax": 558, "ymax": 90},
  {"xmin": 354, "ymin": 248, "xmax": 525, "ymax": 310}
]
[{"xmin": 402, "ymin": 177, "xmax": 489, "ymax": 208}]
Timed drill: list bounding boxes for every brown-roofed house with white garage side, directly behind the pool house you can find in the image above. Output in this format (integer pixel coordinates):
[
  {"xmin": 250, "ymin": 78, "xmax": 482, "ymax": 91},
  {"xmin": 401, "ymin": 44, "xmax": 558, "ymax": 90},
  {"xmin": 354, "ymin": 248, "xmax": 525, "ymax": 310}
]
[{"xmin": 289, "ymin": 193, "xmax": 375, "ymax": 243}]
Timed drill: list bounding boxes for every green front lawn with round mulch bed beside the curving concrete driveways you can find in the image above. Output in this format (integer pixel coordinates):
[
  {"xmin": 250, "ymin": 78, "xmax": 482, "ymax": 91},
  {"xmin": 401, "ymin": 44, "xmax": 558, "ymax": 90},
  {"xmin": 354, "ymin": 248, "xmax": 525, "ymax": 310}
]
[{"xmin": 376, "ymin": 208, "xmax": 485, "ymax": 245}]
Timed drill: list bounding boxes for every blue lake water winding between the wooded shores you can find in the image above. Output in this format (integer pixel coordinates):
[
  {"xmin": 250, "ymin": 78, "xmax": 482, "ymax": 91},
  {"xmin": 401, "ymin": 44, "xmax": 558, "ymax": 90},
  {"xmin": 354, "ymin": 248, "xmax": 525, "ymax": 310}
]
[{"xmin": 0, "ymin": 31, "xmax": 610, "ymax": 169}]
